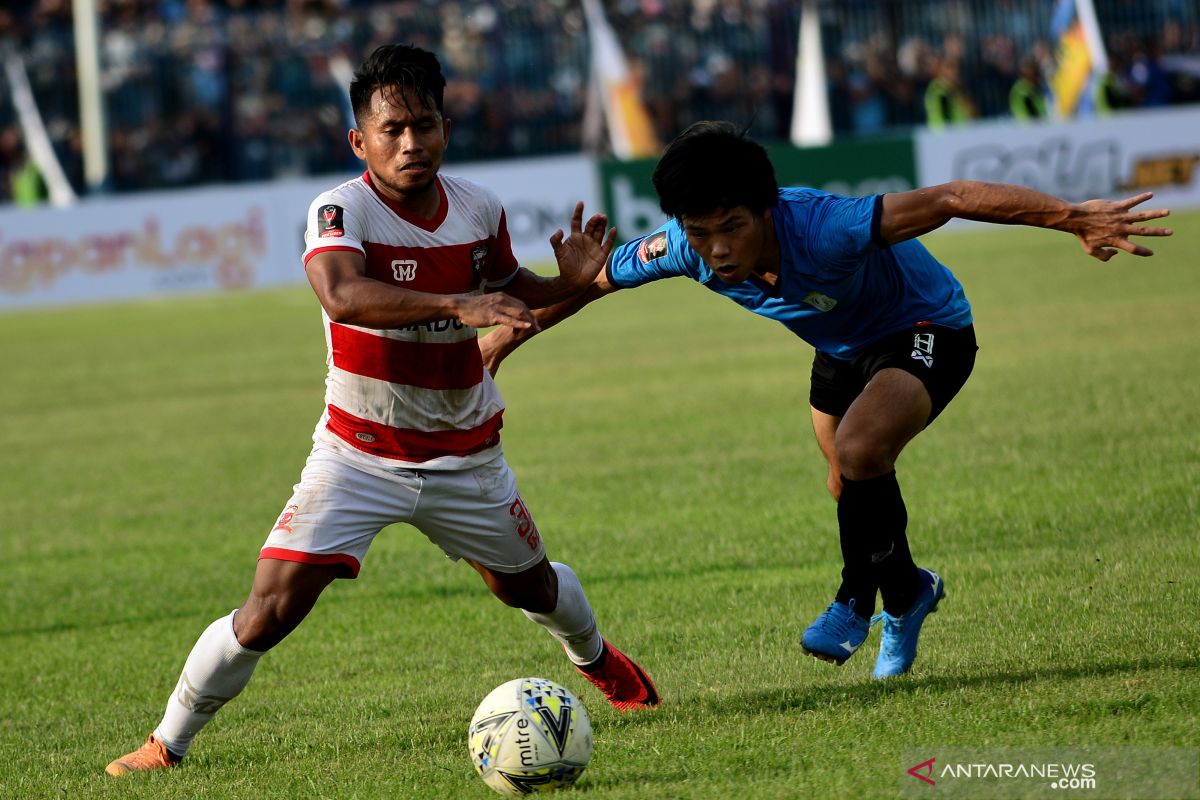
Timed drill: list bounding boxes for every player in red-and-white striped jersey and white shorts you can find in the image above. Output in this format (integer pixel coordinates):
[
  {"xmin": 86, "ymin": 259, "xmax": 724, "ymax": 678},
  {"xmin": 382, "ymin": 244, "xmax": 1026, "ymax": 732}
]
[{"xmin": 106, "ymin": 46, "xmax": 659, "ymax": 776}]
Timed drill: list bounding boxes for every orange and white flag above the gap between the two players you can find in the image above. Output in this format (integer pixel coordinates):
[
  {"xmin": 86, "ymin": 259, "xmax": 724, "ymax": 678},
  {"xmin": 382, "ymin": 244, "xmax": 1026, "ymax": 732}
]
[{"xmin": 583, "ymin": 0, "xmax": 660, "ymax": 158}]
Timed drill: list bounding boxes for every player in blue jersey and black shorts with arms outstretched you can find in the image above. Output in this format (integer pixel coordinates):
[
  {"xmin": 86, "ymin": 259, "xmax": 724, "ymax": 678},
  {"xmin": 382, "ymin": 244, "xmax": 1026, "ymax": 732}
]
[{"xmin": 480, "ymin": 122, "xmax": 1171, "ymax": 679}]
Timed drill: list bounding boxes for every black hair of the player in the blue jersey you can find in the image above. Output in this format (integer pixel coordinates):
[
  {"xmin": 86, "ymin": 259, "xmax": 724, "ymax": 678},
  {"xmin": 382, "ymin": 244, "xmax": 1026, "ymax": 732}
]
[{"xmin": 652, "ymin": 121, "xmax": 779, "ymax": 218}]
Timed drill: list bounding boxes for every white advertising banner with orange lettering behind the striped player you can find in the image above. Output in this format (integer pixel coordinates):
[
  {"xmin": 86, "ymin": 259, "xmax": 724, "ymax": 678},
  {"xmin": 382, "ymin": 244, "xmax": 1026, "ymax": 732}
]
[{"xmin": 0, "ymin": 156, "xmax": 599, "ymax": 311}]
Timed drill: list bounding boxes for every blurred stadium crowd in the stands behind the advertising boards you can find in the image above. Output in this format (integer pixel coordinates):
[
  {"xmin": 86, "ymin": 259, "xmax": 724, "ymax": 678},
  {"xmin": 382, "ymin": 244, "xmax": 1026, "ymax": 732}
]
[{"xmin": 0, "ymin": 0, "xmax": 1200, "ymax": 201}]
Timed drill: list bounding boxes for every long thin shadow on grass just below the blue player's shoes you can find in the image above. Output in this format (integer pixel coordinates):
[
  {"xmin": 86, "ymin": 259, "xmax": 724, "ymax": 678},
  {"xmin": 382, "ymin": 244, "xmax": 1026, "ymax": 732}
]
[{"xmin": 704, "ymin": 656, "xmax": 1200, "ymax": 714}]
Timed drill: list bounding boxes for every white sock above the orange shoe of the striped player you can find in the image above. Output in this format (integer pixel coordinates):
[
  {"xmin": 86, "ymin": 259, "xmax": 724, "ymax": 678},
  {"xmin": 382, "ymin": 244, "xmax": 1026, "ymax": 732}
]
[{"xmin": 154, "ymin": 609, "xmax": 263, "ymax": 756}]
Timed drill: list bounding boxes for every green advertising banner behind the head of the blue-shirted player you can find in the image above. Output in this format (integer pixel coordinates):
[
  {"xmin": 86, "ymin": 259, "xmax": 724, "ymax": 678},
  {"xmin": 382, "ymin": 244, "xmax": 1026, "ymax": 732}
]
[{"xmin": 599, "ymin": 137, "xmax": 917, "ymax": 241}]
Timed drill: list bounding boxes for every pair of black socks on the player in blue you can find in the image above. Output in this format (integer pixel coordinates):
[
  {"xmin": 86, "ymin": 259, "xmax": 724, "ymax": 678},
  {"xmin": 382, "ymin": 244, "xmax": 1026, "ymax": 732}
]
[{"xmin": 838, "ymin": 473, "xmax": 917, "ymax": 618}]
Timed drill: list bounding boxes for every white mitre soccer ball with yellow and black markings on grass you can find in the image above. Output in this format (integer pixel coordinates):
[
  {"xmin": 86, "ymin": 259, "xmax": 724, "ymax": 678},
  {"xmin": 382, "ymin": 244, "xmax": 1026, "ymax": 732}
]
[{"xmin": 468, "ymin": 678, "xmax": 592, "ymax": 796}]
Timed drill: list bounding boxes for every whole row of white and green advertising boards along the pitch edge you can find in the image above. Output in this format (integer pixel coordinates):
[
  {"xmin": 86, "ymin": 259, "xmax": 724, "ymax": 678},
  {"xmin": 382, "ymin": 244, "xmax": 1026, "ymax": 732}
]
[{"xmin": 0, "ymin": 107, "xmax": 1200, "ymax": 311}]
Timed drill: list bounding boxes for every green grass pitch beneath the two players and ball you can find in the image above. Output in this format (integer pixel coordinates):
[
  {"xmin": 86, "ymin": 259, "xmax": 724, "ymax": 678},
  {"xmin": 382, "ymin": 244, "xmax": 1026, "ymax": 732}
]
[{"xmin": 0, "ymin": 213, "xmax": 1200, "ymax": 800}]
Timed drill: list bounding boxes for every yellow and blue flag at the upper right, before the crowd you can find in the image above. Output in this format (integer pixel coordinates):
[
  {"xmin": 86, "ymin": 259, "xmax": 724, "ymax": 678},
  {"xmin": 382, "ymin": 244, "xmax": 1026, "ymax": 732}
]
[{"xmin": 1050, "ymin": 0, "xmax": 1109, "ymax": 120}]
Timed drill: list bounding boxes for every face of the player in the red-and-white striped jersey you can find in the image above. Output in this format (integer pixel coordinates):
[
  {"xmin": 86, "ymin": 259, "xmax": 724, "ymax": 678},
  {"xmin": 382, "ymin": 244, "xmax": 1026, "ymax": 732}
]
[{"xmin": 349, "ymin": 89, "xmax": 450, "ymax": 204}]
